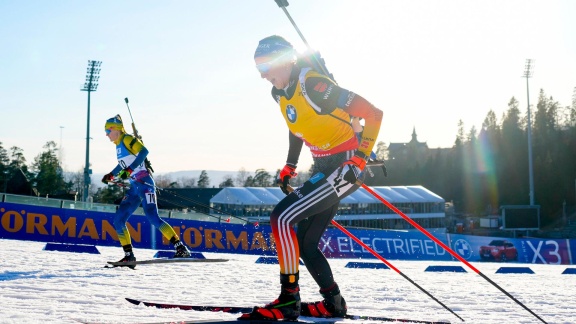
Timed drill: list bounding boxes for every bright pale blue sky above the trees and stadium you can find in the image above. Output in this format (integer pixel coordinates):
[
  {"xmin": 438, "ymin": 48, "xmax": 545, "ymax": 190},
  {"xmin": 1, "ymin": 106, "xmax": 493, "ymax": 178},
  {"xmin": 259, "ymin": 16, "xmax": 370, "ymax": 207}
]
[{"xmin": 0, "ymin": 0, "xmax": 576, "ymax": 177}]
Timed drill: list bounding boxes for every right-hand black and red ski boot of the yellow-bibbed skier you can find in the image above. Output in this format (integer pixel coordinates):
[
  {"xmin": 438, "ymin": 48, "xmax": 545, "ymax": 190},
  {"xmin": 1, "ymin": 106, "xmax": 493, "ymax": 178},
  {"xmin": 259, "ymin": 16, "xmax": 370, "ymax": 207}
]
[{"xmin": 301, "ymin": 283, "xmax": 348, "ymax": 317}]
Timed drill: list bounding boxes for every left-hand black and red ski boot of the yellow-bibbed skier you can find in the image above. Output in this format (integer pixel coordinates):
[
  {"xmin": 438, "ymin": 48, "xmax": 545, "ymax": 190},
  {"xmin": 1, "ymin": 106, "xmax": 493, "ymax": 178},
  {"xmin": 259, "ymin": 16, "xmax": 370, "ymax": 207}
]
[{"xmin": 238, "ymin": 273, "xmax": 300, "ymax": 321}]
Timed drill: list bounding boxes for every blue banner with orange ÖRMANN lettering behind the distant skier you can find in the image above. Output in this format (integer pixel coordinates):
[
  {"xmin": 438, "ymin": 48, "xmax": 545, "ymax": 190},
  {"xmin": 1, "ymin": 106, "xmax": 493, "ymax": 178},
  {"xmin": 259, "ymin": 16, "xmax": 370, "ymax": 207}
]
[{"xmin": 0, "ymin": 203, "xmax": 275, "ymax": 255}]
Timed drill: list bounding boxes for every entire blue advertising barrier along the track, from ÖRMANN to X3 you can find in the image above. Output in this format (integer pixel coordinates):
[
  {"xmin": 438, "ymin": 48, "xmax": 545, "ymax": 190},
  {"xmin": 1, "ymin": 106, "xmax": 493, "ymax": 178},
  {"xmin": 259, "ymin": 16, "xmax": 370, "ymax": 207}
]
[{"xmin": 0, "ymin": 202, "xmax": 576, "ymax": 264}]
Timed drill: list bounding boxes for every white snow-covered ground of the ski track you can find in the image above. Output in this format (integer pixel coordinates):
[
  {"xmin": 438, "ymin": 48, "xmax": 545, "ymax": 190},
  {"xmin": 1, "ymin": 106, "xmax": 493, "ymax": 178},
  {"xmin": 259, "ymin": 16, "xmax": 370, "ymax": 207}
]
[{"xmin": 0, "ymin": 240, "xmax": 576, "ymax": 324}]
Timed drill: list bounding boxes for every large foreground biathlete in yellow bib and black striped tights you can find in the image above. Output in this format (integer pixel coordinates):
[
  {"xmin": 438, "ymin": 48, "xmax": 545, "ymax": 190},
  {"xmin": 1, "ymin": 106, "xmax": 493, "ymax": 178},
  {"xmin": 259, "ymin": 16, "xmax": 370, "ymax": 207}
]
[{"xmin": 241, "ymin": 36, "xmax": 382, "ymax": 320}]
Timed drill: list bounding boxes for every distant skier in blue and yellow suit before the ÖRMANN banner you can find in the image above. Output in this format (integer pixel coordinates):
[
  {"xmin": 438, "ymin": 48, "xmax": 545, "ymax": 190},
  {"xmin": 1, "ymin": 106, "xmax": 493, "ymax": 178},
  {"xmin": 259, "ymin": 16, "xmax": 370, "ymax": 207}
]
[{"xmin": 102, "ymin": 115, "xmax": 190, "ymax": 268}]
